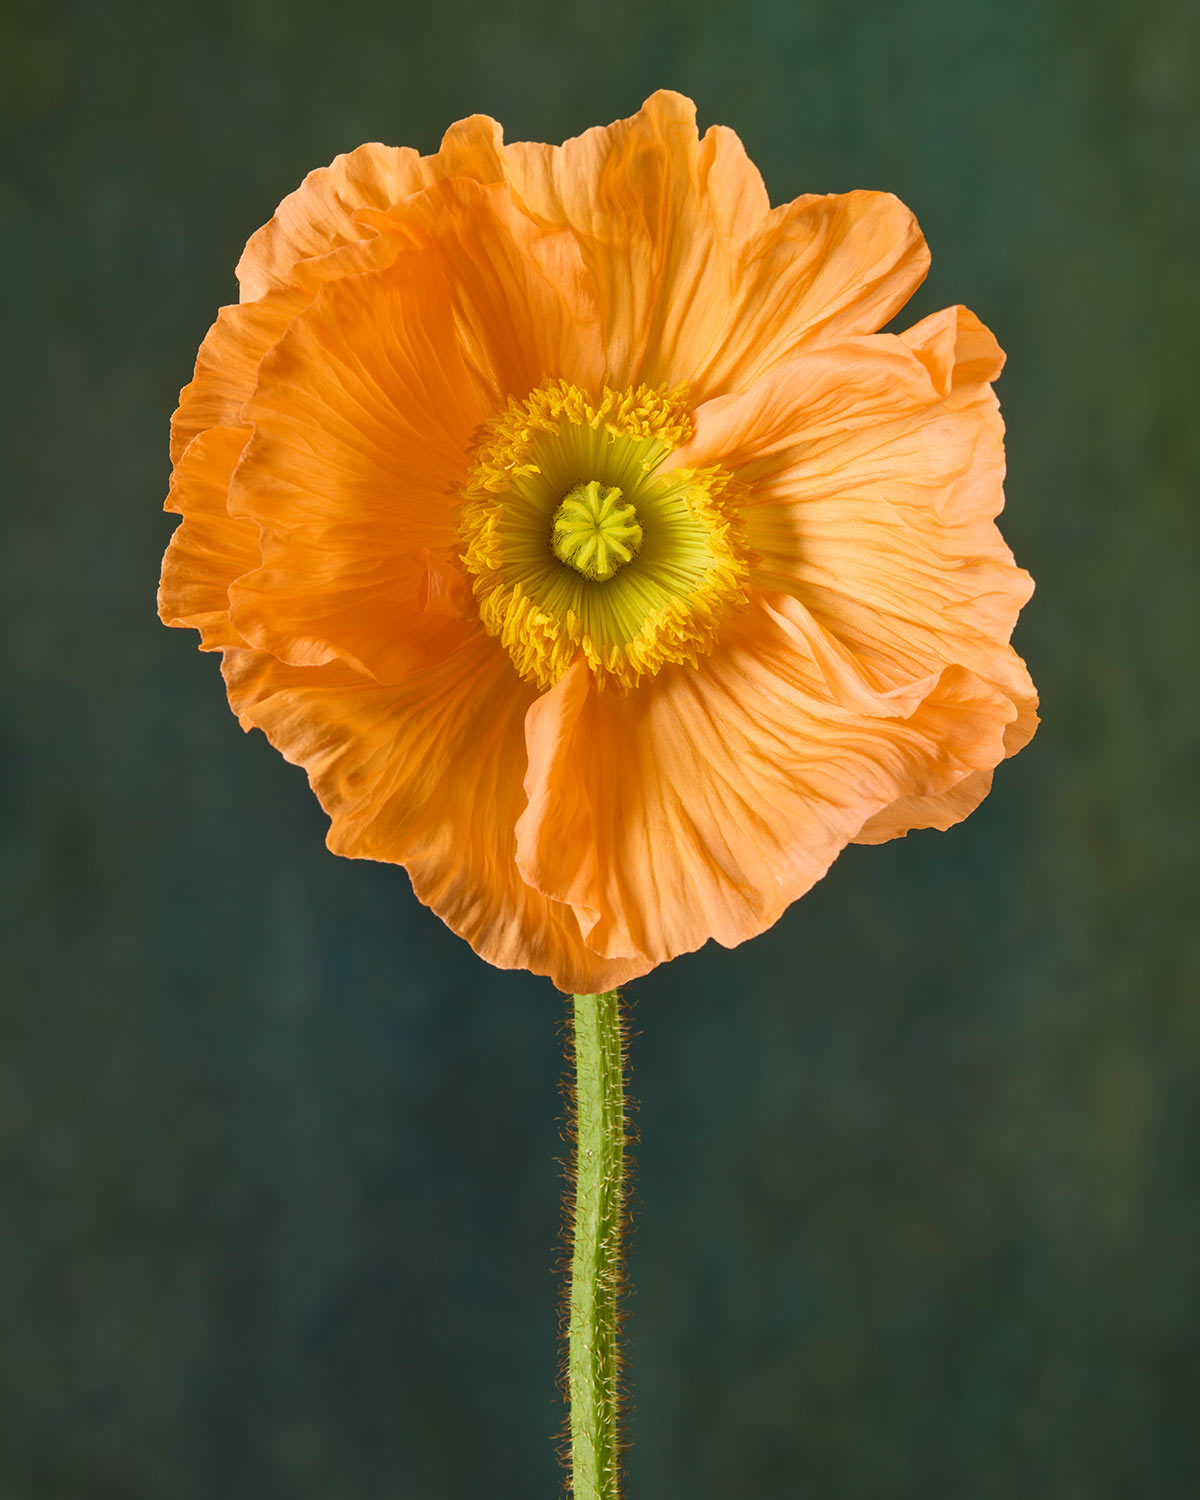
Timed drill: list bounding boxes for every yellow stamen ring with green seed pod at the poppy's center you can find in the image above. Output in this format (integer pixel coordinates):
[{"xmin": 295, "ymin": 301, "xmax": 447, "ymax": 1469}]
[{"xmin": 459, "ymin": 381, "xmax": 752, "ymax": 690}]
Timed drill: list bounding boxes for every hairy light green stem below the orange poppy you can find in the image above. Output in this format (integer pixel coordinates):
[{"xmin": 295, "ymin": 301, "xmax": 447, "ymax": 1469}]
[{"xmin": 567, "ymin": 990, "xmax": 626, "ymax": 1500}]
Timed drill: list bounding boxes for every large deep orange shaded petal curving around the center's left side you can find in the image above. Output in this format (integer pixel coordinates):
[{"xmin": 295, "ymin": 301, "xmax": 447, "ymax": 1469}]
[{"xmin": 230, "ymin": 182, "xmax": 600, "ymax": 683}]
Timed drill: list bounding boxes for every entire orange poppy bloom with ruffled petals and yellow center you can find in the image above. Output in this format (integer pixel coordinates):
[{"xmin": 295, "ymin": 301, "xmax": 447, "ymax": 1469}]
[{"xmin": 161, "ymin": 93, "xmax": 1037, "ymax": 992}]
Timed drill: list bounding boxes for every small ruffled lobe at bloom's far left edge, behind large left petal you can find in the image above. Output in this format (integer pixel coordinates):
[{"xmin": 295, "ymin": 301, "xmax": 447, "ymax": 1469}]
[{"xmin": 159, "ymin": 428, "xmax": 261, "ymax": 651}]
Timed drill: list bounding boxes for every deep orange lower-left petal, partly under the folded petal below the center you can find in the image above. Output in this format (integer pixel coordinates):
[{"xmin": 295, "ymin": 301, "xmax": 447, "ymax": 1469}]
[{"xmin": 224, "ymin": 632, "xmax": 645, "ymax": 993}]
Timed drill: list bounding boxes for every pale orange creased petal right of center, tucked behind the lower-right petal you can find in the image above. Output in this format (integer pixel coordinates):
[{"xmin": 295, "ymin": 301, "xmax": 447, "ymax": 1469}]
[{"xmin": 672, "ymin": 308, "xmax": 1037, "ymax": 840}]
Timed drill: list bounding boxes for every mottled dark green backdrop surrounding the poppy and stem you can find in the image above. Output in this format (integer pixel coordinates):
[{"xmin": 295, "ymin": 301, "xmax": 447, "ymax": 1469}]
[{"xmin": 0, "ymin": 0, "xmax": 1200, "ymax": 1500}]
